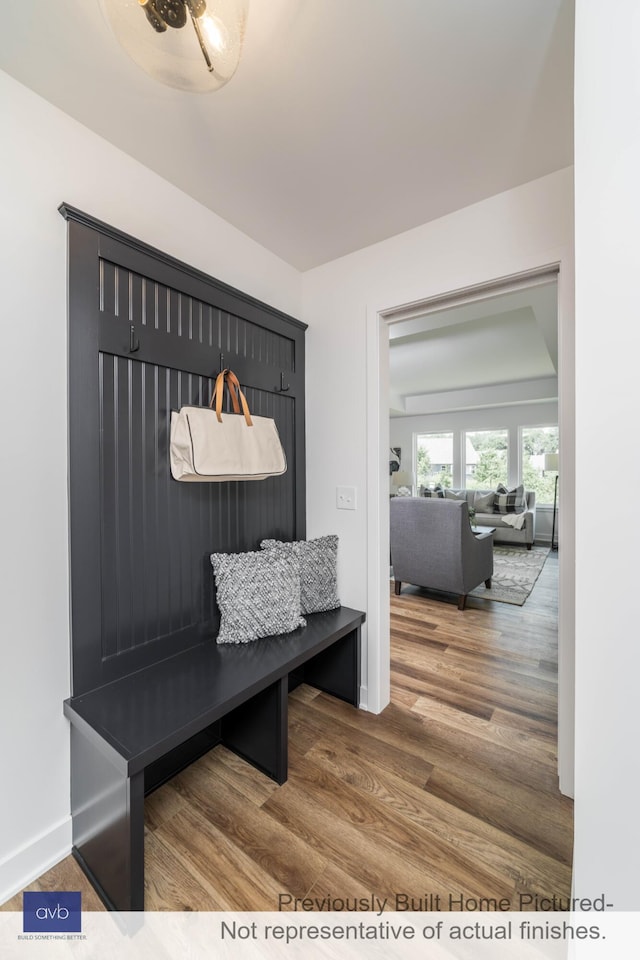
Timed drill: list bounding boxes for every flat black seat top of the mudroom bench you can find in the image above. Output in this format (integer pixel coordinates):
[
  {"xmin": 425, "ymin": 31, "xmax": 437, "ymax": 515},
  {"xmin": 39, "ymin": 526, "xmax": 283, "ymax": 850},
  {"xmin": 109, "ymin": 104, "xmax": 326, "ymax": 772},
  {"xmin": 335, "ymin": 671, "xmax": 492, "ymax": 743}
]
[{"xmin": 64, "ymin": 607, "xmax": 365, "ymax": 773}]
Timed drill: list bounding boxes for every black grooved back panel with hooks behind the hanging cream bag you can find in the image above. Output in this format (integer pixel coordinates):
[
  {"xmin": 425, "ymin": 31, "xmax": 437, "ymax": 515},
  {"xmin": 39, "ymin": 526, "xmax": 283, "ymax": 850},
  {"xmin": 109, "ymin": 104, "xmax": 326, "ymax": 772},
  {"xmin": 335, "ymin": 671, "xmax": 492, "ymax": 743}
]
[{"xmin": 69, "ymin": 208, "xmax": 304, "ymax": 695}]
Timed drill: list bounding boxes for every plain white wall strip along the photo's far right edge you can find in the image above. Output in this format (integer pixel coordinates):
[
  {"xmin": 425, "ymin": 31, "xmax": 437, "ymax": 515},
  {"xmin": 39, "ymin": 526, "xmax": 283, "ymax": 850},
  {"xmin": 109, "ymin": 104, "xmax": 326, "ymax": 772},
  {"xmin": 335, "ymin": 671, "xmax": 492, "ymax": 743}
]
[{"xmin": 574, "ymin": 0, "xmax": 640, "ymax": 912}]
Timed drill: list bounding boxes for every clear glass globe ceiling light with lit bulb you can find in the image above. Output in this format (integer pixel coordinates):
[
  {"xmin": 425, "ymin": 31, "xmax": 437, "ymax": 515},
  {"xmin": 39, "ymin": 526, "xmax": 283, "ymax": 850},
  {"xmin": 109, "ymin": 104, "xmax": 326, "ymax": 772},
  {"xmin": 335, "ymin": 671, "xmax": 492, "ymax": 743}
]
[{"xmin": 102, "ymin": 0, "xmax": 249, "ymax": 93}]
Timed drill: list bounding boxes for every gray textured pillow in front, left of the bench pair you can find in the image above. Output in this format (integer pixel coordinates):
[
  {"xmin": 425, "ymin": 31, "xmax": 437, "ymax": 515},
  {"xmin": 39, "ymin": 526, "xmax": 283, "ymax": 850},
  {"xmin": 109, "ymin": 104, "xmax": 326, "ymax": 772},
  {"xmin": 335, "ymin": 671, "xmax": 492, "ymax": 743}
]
[{"xmin": 211, "ymin": 551, "xmax": 306, "ymax": 643}]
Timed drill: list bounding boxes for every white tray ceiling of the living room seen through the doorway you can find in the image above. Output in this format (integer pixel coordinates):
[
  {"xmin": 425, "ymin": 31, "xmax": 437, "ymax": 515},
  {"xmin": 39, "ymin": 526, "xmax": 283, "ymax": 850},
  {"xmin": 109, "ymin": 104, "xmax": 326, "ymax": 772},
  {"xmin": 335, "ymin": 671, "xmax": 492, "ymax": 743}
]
[{"xmin": 389, "ymin": 279, "xmax": 558, "ymax": 416}]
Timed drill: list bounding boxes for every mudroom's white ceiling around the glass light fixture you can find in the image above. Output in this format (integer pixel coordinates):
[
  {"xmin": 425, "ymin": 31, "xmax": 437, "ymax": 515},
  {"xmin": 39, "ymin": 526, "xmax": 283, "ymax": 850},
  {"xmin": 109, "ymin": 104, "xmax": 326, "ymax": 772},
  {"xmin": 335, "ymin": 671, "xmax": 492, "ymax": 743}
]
[{"xmin": 0, "ymin": 0, "xmax": 573, "ymax": 270}]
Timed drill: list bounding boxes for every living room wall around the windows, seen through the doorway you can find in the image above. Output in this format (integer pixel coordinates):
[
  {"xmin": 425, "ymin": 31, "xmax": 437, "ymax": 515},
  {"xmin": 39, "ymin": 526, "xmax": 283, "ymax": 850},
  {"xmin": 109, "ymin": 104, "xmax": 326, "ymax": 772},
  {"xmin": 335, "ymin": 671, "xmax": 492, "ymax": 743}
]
[{"xmin": 389, "ymin": 402, "xmax": 558, "ymax": 543}]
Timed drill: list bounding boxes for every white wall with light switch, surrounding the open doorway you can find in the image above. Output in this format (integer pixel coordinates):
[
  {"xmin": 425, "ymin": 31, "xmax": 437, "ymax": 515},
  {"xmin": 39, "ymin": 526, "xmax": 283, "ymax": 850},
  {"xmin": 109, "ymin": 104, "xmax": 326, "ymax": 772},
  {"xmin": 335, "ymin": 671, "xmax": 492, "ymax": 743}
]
[{"xmin": 303, "ymin": 161, "xmax": 573, "ymax": 772}]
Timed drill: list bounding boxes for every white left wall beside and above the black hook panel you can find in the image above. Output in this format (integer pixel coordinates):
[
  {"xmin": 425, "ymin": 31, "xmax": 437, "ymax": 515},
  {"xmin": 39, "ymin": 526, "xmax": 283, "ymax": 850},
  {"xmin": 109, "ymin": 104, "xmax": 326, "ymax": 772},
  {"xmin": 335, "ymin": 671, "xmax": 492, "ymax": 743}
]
[{"xmin": 0, "ymin": 73, "xmax": 301, "ymax": 902}]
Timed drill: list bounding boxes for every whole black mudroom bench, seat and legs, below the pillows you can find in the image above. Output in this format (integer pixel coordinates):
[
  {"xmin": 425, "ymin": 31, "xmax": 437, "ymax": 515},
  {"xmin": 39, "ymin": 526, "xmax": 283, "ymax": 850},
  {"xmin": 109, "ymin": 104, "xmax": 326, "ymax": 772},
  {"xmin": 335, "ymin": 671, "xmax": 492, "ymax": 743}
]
[{"xmin": 64, "ymin": 607, "xmax": 365, "ymax": 910}]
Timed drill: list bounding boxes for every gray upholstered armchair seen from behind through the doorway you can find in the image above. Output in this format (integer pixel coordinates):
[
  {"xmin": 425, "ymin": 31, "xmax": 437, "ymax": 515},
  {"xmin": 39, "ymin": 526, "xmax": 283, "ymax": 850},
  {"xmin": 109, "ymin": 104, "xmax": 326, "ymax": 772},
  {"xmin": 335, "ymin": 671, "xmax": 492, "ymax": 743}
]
[{"xmin": 389, "ymin": 497, "xmax": 493, "ymax": 610}]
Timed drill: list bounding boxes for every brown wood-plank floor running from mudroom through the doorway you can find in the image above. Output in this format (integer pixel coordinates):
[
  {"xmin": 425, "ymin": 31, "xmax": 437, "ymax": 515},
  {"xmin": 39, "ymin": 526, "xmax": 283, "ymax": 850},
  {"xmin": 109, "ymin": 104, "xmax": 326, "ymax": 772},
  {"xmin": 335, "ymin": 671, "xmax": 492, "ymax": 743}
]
[{"xmin": 3, "ymin": 554, "xmax": 572, "ymax": 910}]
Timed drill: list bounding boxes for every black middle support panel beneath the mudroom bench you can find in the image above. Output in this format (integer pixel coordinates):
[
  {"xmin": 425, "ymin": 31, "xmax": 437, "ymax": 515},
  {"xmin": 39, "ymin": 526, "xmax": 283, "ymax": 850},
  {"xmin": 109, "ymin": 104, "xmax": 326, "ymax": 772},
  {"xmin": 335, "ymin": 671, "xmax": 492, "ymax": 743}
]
[{"xmin": 222, "ymin": 677, "xmax": 289, "ymax": 783}]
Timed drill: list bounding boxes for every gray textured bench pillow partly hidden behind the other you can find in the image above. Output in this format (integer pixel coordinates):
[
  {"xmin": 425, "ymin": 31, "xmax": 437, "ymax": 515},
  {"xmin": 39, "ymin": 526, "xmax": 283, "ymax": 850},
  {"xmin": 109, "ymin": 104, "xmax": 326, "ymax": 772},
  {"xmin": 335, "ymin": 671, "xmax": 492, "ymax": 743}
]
[{"xmin": 260, "ymin": 534, "xmax": 340, "ymax": 613}]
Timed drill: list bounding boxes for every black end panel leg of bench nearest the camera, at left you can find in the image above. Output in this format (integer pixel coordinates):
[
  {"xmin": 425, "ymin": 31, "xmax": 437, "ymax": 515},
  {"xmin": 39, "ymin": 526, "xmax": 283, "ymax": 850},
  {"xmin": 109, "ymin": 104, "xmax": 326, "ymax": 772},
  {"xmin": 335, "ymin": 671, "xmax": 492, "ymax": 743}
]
[{"xmin": 71, "ymin": 725, "xmax": 144, "ymax": 911}]
